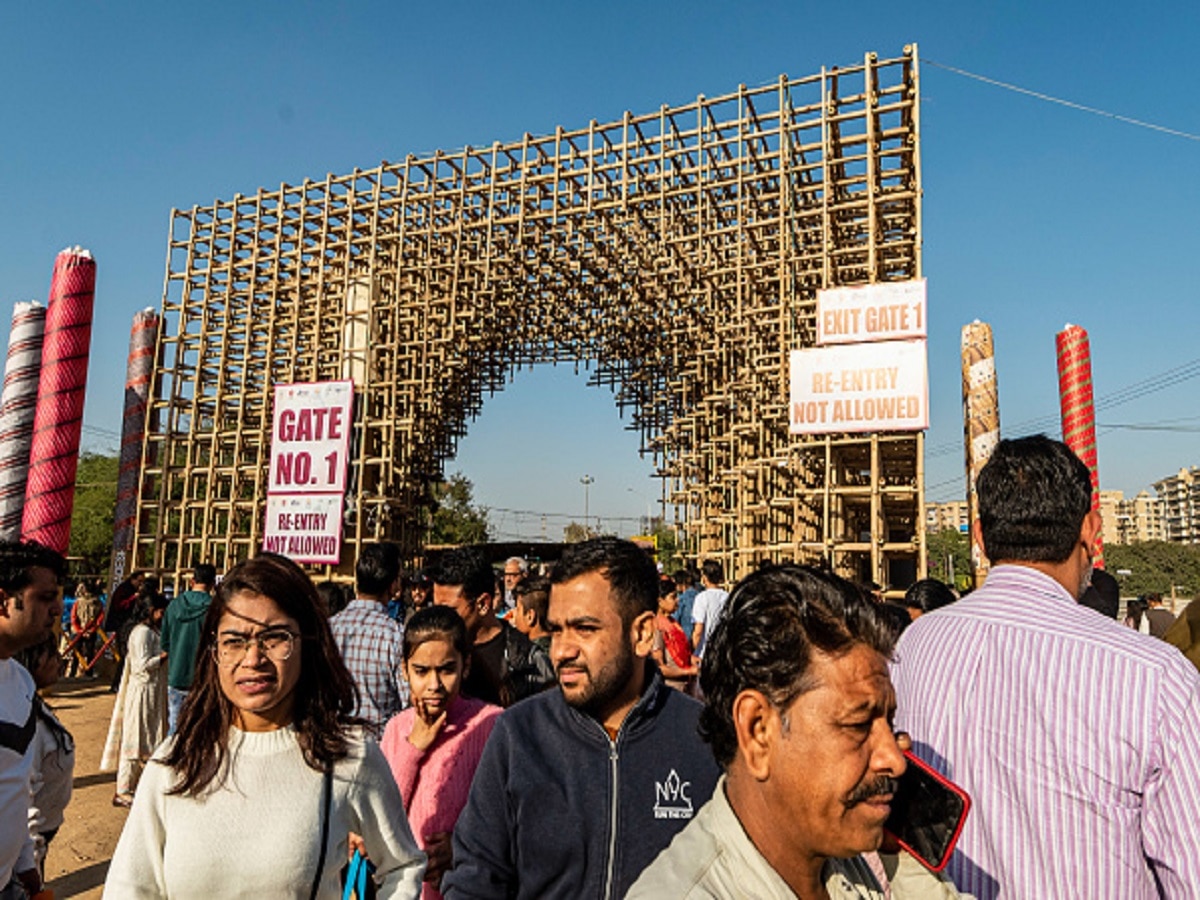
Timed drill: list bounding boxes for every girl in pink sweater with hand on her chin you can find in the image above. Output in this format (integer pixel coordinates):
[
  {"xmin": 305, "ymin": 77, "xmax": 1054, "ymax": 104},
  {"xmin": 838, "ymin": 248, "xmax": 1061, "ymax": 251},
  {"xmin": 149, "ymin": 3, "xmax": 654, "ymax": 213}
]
[{"xmin": 379, "ymin": 606, "xmax": 500, "ymax": 900}]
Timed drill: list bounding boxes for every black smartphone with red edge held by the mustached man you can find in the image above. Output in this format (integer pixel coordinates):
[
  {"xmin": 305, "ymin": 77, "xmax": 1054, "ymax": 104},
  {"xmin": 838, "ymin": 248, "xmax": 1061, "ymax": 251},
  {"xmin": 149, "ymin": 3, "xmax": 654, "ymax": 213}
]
[{"xmin": 883, "ymin": 752, "xmax": 971, "ymax": 872}]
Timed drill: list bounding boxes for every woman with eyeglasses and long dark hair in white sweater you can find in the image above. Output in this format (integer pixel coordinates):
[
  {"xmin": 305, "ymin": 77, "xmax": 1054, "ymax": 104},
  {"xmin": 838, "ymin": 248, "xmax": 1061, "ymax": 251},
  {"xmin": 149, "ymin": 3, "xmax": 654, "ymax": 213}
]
[{"xmin": 104, "ymin": 553, "xmax": 425, "ymax": 900}]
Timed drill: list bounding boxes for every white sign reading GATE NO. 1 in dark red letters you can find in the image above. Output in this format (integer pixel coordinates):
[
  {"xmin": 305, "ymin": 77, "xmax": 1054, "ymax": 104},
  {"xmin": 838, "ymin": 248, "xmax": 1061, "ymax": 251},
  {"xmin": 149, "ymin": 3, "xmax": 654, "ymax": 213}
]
[{"xmin": 266, "ymin": 382, "xmax": 354, "ymax": 493}]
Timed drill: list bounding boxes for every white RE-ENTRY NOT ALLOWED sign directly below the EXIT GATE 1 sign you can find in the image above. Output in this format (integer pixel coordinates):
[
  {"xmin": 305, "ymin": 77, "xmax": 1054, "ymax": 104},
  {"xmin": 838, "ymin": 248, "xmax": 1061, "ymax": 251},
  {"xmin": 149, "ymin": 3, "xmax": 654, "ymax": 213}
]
[{"xmin": 788, "ymin": 341, "xmax": 929, "ymax": 434}]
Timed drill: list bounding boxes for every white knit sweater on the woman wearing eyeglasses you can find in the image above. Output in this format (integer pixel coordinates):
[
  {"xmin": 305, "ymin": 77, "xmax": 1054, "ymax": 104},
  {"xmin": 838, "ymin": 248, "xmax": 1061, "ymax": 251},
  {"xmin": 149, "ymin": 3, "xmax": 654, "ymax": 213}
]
[{"xmin": 104, "ymin": 728, "xmax": 425, "ymax": 900}]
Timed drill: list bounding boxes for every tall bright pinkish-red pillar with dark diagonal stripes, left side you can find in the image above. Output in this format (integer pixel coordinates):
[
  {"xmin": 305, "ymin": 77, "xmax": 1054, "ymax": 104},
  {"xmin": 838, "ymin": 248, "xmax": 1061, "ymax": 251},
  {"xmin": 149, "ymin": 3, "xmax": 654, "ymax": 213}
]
[{"xmin": 22, "ymin": 247, "xmax": 96, "ymax": 553}]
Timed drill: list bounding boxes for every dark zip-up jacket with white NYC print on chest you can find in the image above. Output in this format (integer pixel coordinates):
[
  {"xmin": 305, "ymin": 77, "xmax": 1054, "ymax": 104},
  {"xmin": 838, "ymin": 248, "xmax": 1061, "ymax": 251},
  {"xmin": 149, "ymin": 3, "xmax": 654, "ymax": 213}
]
[{"xmin": 442, "ymin": 662, "xmax": 720, "ymax": 900}]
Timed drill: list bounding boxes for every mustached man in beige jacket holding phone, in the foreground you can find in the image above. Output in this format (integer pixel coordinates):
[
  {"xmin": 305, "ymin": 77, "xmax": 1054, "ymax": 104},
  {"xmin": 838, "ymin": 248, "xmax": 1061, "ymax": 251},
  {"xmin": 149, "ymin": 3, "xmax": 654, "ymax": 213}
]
[{"xmin": 629, "ymin": 565, "xmax": 959, "ymax": 900}]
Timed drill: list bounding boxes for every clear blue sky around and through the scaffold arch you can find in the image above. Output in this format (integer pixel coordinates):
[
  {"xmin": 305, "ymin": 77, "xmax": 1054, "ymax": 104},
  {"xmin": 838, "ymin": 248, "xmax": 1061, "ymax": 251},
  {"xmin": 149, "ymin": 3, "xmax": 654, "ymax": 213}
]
[{"xmin": 0, "ymin": 2, "xmax": 1200, "ymax": 538}]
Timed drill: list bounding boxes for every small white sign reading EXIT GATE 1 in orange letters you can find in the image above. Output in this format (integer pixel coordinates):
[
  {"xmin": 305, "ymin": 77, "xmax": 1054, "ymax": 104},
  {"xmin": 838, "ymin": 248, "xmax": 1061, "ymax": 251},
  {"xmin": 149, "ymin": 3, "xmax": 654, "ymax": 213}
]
[{"xmin": 817, "ymin": 278, "xmax": 926, "ymax": 347}]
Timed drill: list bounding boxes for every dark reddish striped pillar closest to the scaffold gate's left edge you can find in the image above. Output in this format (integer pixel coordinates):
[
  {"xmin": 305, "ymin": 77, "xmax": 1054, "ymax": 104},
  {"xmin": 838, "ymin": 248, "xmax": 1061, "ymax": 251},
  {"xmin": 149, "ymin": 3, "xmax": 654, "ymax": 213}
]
[{"xmin": 110, "ymin": 308, "xmax": 158, "ymax": 589}]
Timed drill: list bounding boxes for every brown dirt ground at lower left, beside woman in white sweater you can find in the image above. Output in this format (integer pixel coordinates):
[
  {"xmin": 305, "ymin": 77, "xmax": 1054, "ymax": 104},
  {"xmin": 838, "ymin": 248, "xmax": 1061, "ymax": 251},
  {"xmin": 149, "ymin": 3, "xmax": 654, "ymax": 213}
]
[{"xmin": 46, "ymin": 671, "xmax": 127, "ymax": 900}]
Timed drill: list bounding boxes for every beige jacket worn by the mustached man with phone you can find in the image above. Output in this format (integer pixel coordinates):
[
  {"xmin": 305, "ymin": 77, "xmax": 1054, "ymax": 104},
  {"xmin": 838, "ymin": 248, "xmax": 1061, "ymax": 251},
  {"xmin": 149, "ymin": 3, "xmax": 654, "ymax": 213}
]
[{"xmin": 626, "ymin": 776, "xmax": 968, "ymax": 900}]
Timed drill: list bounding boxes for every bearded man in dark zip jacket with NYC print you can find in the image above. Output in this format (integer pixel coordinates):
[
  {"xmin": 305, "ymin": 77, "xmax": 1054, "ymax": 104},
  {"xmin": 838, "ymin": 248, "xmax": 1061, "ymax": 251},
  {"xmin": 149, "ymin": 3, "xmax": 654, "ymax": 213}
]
[{"xmin": 442, "ymin": 538, "xmax": 720, "ymax": 900}]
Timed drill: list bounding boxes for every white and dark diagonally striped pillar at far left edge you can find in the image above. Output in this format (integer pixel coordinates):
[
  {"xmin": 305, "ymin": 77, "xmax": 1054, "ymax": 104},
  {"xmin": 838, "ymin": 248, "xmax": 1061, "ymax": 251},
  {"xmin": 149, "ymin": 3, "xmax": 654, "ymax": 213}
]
[{"xmin": 0, "ymin": 300, "xmax": 46, "ymax": 541}]
